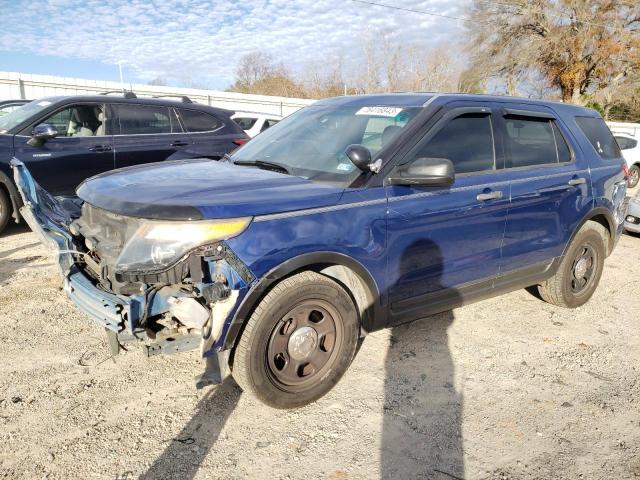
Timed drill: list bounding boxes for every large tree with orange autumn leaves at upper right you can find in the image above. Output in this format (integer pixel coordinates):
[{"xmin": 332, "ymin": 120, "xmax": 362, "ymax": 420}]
[{"xmin": 469, "ymin": 0, "xmax": 640, "ymax": 104}]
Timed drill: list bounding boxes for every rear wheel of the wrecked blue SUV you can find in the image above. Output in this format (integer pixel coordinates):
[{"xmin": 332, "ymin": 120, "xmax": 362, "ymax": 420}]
[{"xmin": 538, "ymin": 222, "xmax": 609, "ymax": 308}]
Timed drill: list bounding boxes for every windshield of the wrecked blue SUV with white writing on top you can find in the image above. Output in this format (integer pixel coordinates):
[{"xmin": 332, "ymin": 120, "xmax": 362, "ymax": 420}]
[{"xmin": 231, "ymin": 105, "xmax": 421, "ymax": 184}]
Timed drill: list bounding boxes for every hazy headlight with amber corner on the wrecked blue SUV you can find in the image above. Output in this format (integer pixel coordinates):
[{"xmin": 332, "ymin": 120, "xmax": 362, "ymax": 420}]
[{"xmin": 116, "ymin": 217, "xmax": 251, "ymax": 272}]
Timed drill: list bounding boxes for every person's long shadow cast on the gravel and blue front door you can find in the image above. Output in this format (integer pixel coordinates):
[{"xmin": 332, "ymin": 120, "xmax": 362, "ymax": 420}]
[{"xmin": 380, "ymin": 239, "xmax": 464, "ymax": 479}]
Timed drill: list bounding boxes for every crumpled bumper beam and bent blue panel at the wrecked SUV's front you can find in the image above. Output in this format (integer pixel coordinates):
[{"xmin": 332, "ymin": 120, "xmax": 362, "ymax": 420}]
[{"xmin": 11, "ymin": 159, "xmax": 146, "ymax": 334}]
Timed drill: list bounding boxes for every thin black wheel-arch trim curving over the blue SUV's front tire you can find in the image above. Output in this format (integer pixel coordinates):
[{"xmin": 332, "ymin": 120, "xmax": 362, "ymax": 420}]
[{"xmin": 222, "ymin": 252, "xmax": 384, "ymax": 350}]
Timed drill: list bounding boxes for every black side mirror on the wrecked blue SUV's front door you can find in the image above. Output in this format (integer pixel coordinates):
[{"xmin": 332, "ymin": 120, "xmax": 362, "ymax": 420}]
[{"xmin": 387, "ymin": 158, "xmax": 455, "ymax": 187}]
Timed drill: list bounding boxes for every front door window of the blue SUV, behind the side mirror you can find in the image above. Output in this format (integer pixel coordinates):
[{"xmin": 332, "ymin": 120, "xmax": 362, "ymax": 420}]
[{"xmin": 413, "ymin": 113, "xmax": 494, "ymax": 174}]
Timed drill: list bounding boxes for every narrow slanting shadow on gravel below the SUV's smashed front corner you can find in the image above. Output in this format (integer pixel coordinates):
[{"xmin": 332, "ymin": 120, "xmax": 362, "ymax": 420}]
[{"xmin": 140, "ymin": 378, "xmax": 242, "ymax": 480}]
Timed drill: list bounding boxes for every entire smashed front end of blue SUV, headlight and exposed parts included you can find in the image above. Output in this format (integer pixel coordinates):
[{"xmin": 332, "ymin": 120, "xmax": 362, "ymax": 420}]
[{"xmin": 12, "ymin": 159, "xmax": 254, "ymax": 386}]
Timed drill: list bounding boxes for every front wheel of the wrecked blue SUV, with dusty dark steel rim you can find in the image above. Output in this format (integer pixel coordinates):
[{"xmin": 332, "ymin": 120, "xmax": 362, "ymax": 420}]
[{"xmin": 232, "ymin": 272, "xmax": 360, "ymax": 408}]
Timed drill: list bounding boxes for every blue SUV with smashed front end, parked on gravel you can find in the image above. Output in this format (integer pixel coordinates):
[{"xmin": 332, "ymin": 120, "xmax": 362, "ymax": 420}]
[{"xmin": 14, "ymin": 94, "xmax": 626, "ymax": 408}]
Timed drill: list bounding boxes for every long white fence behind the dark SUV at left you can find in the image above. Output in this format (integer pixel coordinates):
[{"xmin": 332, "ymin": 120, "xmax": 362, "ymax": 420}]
[{"xmin": 0, "ymin": 72, "xmax": 314, "ymax": 116}]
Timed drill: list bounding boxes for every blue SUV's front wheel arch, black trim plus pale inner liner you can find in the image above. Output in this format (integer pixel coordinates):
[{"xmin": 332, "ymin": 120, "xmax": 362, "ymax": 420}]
[{"xmin": 222, "ymin": 252, "xmax": 381, "ymax": 350}]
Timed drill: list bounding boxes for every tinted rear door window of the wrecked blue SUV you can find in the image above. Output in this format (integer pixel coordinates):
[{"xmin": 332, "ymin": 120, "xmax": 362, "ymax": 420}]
[{"xmin": 504, "ymin": 117, "xmax": 566, "ymax": 168}]
